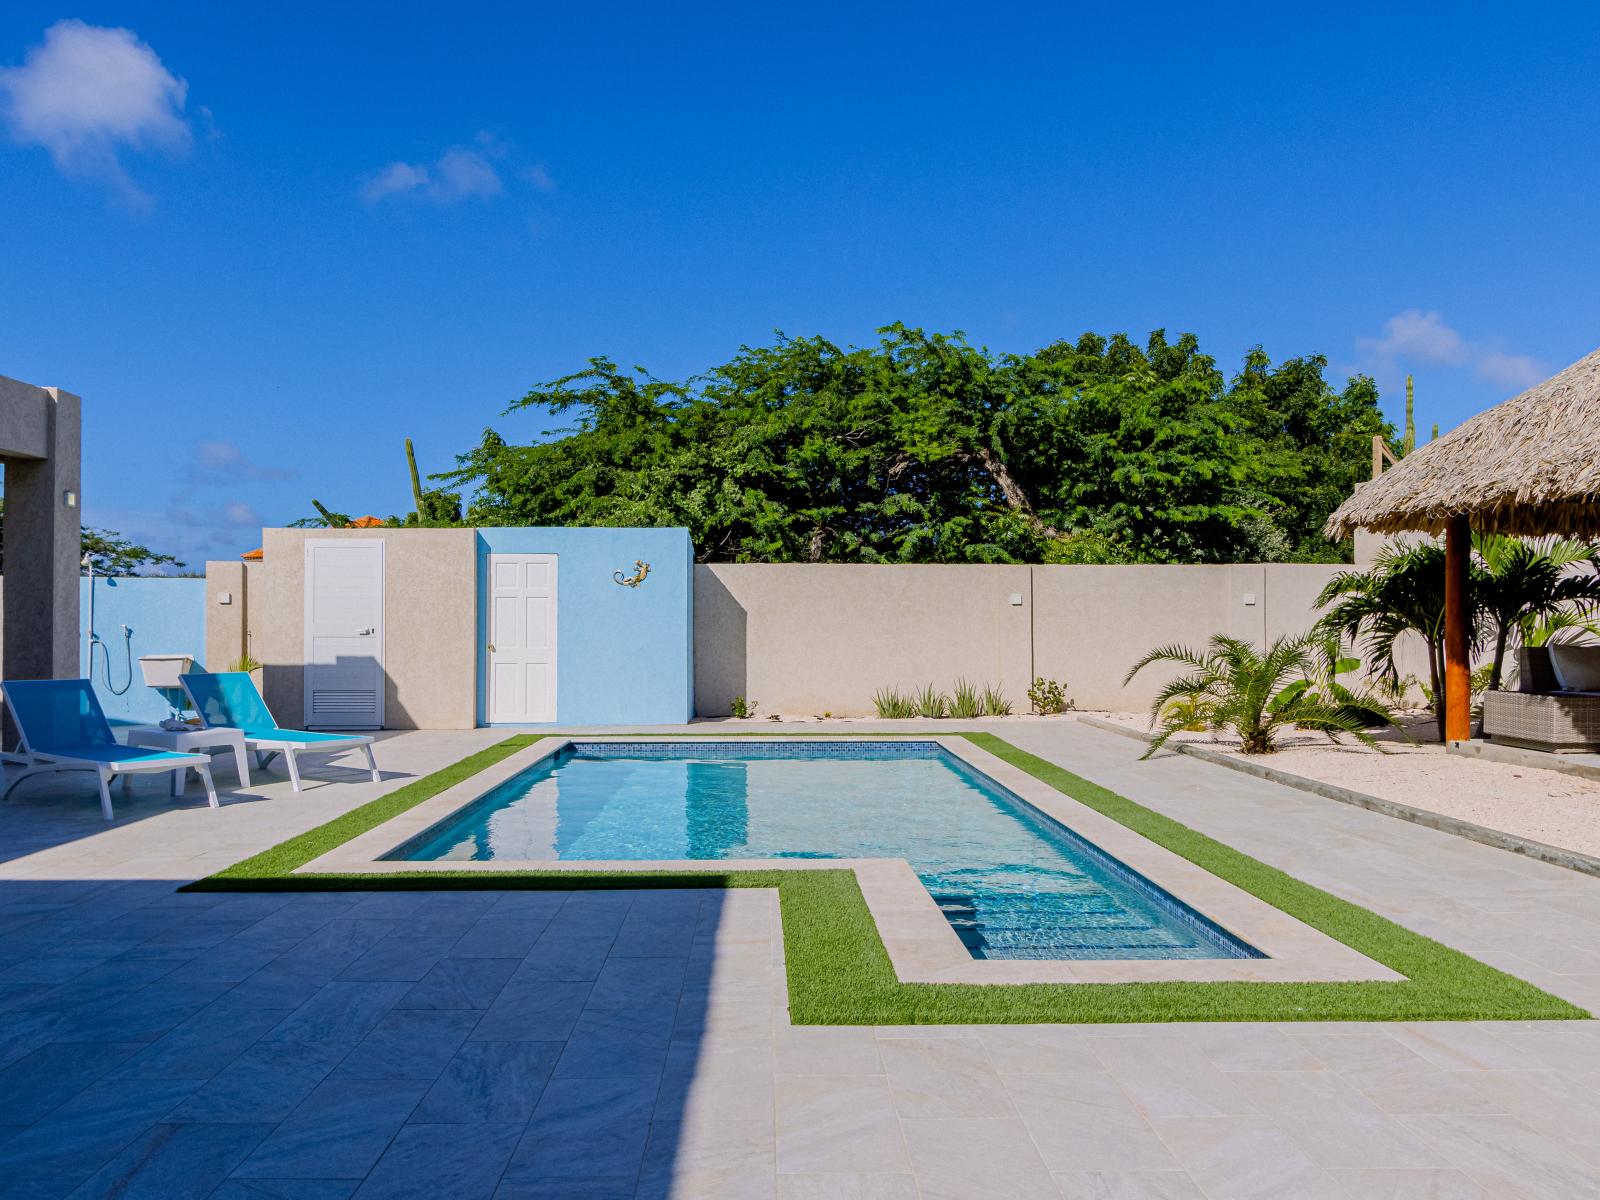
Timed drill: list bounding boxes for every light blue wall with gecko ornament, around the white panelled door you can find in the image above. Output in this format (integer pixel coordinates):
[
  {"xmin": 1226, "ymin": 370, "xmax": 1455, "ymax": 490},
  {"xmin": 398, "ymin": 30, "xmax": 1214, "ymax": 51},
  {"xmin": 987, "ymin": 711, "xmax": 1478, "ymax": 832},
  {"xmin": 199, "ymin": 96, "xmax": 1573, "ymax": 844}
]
[{"xmin": 477, "ymin": 528, "xmax": 694, "ymax": 725}]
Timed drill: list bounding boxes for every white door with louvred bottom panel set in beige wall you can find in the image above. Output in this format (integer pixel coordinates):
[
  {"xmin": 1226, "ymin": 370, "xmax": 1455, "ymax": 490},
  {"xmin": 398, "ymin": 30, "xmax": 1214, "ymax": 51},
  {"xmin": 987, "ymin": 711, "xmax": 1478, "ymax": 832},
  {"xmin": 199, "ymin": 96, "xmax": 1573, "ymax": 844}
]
[{"xmin": 306, "ymin": 538, "xmax": 384, "ymax": 730}]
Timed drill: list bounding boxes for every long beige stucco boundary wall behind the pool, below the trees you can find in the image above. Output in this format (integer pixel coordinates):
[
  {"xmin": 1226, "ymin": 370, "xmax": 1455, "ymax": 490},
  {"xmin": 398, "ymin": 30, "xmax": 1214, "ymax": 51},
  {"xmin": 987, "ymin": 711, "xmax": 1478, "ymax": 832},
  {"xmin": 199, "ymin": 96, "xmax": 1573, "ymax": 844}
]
[{"xmin": 694, "ymin": 563, "xmax": 1388, "ymax": 717}]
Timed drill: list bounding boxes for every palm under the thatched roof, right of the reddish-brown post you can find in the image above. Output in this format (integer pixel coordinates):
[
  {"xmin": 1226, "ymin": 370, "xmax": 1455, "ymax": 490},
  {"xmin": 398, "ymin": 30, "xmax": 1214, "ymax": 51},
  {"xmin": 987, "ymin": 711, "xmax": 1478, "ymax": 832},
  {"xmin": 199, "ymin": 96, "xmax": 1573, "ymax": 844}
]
[{"xmin": 1472, "ymin": 533, "xmax": 1600, "ymax": 690}]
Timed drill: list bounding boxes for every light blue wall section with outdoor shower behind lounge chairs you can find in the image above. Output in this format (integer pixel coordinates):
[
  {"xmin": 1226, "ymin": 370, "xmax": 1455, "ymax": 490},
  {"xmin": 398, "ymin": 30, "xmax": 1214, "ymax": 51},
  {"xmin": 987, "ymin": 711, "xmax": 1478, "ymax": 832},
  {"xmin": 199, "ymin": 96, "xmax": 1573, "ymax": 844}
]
[{"xmin": 78, "ymin": 574, "xmax": 205, "ymax": 725}]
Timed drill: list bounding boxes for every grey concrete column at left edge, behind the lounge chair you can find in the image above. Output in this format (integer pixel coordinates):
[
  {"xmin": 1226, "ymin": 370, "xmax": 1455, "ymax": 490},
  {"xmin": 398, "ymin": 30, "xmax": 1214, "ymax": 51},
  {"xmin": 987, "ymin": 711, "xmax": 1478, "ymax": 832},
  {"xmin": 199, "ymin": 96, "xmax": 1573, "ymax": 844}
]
[{"xmin": 0, "ymin": 390, "xmax": 83, "ymax": 678}]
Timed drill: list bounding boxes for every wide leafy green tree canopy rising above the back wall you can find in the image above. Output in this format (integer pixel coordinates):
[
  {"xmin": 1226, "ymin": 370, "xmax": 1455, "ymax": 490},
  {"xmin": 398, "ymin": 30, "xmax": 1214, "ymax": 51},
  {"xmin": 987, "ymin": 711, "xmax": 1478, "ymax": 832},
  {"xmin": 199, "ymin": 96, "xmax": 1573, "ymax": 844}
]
[{"xmin": 437, "ymin": 325, "xmax": 1394, "ymax": 563}]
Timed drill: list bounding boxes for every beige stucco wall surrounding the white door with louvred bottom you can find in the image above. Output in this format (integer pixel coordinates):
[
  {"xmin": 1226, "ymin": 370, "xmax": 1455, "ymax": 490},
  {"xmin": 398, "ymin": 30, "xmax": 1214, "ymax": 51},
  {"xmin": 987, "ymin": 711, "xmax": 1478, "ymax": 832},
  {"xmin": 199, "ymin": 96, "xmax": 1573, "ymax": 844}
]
[{"xmin": 249, "ymin": 530, "xmax": 478, "ymax": 730}]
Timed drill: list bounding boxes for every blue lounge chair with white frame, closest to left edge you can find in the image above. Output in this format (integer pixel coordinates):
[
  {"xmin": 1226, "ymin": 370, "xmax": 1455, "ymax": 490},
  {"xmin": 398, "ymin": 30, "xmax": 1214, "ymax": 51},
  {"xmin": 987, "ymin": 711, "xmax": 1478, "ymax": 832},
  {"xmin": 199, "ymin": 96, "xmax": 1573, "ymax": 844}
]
[{"xmin": 0, "ymin": 678, "xmax": 218, "ymax": 821}]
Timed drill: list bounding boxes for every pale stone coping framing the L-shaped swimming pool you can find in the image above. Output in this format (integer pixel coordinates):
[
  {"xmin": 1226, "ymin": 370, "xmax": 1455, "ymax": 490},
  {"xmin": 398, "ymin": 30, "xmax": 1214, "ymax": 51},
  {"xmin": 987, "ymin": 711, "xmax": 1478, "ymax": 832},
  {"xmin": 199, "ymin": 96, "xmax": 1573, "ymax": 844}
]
[{"xmin": 294, "ymin": 734, "xmax": 1405, "ymax": 984}]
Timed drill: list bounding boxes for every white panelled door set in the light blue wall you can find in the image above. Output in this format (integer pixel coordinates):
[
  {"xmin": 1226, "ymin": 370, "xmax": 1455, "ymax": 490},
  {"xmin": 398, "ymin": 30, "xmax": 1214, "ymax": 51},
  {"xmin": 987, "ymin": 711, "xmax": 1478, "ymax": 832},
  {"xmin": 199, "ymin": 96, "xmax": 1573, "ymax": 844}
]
[{"xmin": 483, "ymin": 554, "xmax": 555, "ymax": 725}]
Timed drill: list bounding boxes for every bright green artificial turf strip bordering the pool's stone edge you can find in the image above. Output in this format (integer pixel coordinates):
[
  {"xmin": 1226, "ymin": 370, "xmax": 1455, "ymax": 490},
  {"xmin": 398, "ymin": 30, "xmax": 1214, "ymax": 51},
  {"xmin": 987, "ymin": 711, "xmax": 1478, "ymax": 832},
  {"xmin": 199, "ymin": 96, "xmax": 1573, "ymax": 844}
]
[{"xmin": 184, "ymin": 730, "xmax": 1589, "ymax": 1026}]
